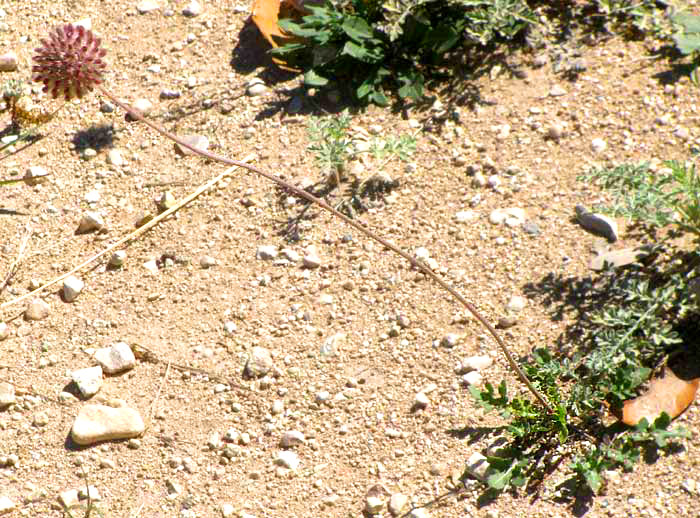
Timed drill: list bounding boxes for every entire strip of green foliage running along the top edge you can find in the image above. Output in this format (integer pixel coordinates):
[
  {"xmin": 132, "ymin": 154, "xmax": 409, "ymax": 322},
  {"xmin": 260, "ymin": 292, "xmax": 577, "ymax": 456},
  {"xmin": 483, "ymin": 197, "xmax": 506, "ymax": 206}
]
[{"xmin": 272, "ymin": 0, "xmax": 680, "ymax": 106}]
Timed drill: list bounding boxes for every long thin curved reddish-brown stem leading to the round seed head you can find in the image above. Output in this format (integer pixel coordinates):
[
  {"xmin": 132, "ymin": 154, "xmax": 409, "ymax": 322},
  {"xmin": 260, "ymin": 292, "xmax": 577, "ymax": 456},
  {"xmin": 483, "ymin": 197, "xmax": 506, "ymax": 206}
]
[{"xmin": 97, "ymin": 85, "xmax": 553, "ymax": 413}]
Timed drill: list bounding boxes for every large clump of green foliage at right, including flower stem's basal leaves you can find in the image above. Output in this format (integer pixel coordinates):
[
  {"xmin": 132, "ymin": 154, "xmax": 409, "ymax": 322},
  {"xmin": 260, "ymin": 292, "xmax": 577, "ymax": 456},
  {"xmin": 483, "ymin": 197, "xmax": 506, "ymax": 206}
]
[{"xmin": 470, "ymin": 162, "xmax": 700, "ymax": 493}]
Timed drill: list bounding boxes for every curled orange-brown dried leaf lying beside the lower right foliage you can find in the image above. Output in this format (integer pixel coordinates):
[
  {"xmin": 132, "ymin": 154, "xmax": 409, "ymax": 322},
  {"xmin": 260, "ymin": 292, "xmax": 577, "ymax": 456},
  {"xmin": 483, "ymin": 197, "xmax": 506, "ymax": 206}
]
[{"xmin": 622, "ymin": 367, "xmax": 700, "ymax": 426}]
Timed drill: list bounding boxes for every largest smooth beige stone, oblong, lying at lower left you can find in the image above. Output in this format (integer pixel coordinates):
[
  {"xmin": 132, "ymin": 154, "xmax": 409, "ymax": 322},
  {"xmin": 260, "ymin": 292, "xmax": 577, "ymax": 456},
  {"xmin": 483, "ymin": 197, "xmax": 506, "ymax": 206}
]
[{"xmin": 71, "ymin": 405, "xmax": 145, "ymax": 446}]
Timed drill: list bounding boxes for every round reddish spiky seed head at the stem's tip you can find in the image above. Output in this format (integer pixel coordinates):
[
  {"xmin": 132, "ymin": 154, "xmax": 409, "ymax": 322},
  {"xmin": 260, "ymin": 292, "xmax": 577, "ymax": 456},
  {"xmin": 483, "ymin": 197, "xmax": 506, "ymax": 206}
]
[{"xmin": 32, "ymin": 24, "xmax": 107, "ymax": 101}]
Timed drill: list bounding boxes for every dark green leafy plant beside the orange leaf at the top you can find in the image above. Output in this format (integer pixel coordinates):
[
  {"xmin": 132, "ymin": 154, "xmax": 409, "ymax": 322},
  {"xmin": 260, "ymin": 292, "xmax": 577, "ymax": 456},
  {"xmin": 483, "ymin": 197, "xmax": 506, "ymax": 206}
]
[{"xmin": 272, "ymin": 0, "xmax": 535, "ymax": 106}]
